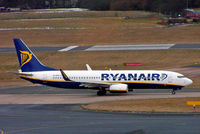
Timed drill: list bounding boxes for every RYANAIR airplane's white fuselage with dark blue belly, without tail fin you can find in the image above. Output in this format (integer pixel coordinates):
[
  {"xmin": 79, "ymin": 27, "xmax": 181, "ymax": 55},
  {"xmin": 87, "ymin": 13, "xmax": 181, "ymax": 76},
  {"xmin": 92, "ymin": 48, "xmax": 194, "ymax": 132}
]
[{"xmin": 21, "ymin": 70, "xmax": 192, "ymax": 89}]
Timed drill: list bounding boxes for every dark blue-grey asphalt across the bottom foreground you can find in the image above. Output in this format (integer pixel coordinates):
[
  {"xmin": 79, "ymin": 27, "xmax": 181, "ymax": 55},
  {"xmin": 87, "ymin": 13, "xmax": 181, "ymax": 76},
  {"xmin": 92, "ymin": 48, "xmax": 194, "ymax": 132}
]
[{"xmin": 0, "ymin": 105, "xmax": 200, "ymax": 134}]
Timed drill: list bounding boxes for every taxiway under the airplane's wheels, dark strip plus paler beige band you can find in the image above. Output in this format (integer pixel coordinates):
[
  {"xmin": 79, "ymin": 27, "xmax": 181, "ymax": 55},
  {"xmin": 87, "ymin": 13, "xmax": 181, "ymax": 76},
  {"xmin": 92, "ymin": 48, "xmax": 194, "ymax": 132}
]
[{"xmin": 0, "ymin": 86, "xmax": 200, "ymax": 104}]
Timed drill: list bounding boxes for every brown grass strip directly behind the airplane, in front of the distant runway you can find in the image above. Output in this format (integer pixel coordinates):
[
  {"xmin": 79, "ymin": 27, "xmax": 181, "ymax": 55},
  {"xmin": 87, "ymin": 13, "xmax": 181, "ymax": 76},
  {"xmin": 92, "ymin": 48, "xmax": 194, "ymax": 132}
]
[{"xmin": 0, "ymin": 50, "xmax": 200, "ymax": 88}]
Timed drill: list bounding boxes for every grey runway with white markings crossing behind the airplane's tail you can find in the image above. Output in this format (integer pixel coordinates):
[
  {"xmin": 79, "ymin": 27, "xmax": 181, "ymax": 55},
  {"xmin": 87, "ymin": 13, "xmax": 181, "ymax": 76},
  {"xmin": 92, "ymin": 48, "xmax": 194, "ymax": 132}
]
[{"xmin": 0, "ymin": 44, "xmax": 200, "ymax": 53}]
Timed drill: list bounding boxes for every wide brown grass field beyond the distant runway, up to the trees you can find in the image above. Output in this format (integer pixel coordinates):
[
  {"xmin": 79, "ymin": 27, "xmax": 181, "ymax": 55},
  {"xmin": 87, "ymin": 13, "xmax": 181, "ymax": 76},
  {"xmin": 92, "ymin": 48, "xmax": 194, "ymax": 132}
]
[{"xmin": 0, "ymin": 11, "xmax": 200, "ymax": 47}]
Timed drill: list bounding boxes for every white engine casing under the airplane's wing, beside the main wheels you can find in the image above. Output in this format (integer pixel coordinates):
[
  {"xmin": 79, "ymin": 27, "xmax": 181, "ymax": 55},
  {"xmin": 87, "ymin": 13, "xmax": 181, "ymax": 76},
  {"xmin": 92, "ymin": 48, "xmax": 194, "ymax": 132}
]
[{"xmin": 109, "ymin": 84, "xmax": 128, "ymax": 93}]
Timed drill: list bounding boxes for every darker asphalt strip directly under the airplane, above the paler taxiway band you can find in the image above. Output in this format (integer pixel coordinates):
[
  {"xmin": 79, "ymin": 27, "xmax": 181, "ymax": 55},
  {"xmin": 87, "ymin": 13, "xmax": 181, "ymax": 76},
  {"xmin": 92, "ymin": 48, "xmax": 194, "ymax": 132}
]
[{"xmin": 0, "ymin": 84, "xmax": 200, "ymax": 96}]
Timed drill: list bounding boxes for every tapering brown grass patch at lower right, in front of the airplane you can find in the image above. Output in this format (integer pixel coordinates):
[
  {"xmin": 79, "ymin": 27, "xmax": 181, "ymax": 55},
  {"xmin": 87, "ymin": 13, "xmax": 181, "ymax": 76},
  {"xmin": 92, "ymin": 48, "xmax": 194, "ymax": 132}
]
[{"xmin": 82, "ymin": 98, "xmax": 200, "ymax": 113}]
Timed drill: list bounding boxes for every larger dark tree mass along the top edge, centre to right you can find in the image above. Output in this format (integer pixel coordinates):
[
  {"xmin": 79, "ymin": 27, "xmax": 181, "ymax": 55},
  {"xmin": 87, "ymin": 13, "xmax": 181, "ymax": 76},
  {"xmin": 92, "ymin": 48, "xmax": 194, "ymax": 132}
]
[{"xmin": 78, "ymin": 0, "xmax": 200, "ymax": 14}]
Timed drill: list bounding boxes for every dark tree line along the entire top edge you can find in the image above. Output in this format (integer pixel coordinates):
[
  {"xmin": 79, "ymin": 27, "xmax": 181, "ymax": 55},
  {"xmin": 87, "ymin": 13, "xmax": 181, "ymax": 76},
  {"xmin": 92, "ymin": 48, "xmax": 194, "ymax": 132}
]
[{"xmin": 0, "ymin": 0, "xmax": 200, "ymax": 14}]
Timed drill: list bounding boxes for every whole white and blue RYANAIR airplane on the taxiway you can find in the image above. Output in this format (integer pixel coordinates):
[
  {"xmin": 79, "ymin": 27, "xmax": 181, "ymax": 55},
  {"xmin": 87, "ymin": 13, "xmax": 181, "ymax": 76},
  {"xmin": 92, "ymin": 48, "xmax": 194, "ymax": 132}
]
[{"xmin": 13, "ymin": 39, "xmax": 193, "ymax": 96}]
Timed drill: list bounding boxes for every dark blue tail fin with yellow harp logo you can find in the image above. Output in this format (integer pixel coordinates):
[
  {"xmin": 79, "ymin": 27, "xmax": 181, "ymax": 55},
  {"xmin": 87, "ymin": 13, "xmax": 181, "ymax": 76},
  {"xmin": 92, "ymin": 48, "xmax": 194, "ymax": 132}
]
[{"xmin": 13, "ymin": 39, "xmax": 56, "ymax": 72}]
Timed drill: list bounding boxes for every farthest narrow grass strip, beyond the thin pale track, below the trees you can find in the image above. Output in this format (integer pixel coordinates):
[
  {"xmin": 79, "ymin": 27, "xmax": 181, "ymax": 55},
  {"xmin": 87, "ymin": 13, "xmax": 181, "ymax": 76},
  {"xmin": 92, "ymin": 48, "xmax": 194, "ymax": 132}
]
[{"xmin": 0, "ymin": 10, "xmax": 158, "ymax": 20}]
